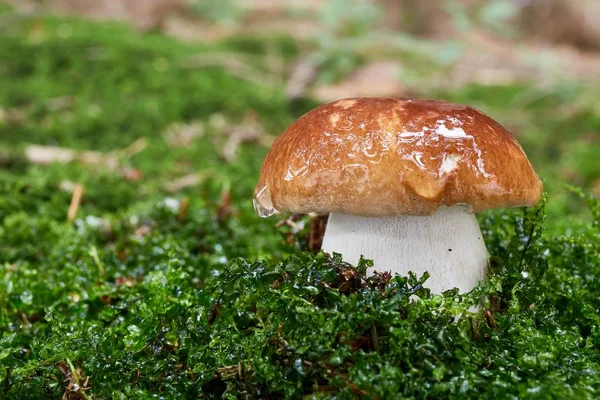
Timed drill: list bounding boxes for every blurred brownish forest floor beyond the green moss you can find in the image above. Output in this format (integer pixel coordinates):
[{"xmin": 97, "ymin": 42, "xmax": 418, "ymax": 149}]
[{"xmin": 9, "ymin": 0, "xmax": 600, "ymax": 90}]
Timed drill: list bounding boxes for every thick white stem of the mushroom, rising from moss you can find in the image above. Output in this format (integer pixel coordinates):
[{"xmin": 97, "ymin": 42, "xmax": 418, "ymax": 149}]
[{"xmin": 322, "ymin": 206, "xmax": 488, "ymax": 293}]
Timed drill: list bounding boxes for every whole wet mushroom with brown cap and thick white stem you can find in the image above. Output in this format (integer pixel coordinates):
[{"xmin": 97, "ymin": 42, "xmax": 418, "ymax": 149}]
[{"xmin": 254, "ymin": 98, "xmax": 542, "ymax": 293}]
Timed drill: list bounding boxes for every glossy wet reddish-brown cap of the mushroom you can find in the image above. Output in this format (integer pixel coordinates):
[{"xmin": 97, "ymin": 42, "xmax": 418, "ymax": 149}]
[{"xmin": 254, "ymin": 98, "xmax": 542, "ymax": 217}]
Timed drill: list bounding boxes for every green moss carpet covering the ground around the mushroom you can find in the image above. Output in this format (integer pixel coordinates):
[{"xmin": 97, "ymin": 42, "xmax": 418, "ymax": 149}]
[{"xmin": 0, "ymin": 7, "xmax": 600, "ymax": 399}]
